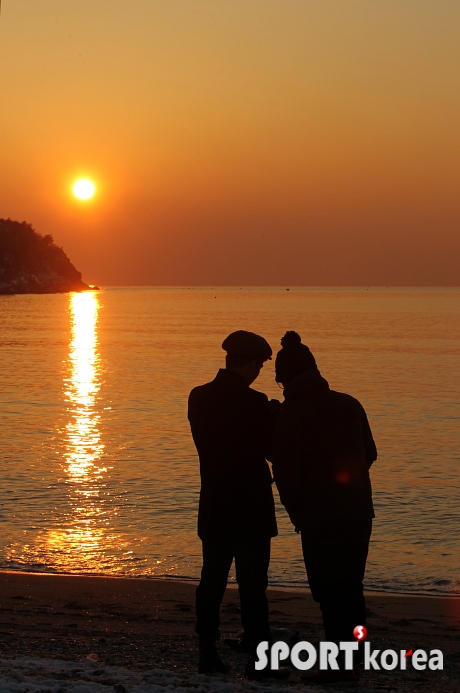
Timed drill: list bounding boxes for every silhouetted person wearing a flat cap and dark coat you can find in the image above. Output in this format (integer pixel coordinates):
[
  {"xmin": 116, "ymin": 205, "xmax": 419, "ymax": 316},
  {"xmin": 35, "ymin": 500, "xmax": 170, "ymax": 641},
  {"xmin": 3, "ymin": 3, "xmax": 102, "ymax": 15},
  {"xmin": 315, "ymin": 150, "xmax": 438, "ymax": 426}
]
[{"xmin": 188, "ymin": 330, "xmax": 277, "ymax": 673}]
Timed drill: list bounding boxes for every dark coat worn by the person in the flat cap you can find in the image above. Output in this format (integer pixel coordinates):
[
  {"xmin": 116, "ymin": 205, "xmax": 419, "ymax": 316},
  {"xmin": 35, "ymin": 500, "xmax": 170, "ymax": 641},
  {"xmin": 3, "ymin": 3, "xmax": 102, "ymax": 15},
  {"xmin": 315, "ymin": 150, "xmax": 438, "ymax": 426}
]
[{"xmin": 188, "ymin": 369, "xmax": 277, "ymax": 539}]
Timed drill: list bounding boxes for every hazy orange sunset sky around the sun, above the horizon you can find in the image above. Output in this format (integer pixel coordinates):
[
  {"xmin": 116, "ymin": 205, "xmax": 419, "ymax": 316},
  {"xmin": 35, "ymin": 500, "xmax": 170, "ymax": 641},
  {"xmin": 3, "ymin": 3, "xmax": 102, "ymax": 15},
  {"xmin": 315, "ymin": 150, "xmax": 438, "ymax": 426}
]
[{"xmin": 0, "ymin": 0, "xmax": 460, "ymax": 286}]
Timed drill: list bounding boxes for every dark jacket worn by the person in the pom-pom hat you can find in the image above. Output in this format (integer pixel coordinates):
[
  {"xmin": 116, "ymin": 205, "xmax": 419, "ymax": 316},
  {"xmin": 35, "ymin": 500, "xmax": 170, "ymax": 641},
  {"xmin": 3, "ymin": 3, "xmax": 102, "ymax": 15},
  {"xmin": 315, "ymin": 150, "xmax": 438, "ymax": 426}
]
[{"xmin": 272, "ymin": 371, "xmax": 377, "ymax": 530}]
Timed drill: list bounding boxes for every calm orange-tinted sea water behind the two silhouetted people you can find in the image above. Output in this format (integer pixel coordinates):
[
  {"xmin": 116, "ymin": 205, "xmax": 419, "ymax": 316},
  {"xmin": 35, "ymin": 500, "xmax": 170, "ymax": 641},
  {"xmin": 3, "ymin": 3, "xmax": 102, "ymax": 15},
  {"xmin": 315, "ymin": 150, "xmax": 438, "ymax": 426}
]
[{"xmin": 0, "ymin": 288, "xmax": 460, "ymax": 594}]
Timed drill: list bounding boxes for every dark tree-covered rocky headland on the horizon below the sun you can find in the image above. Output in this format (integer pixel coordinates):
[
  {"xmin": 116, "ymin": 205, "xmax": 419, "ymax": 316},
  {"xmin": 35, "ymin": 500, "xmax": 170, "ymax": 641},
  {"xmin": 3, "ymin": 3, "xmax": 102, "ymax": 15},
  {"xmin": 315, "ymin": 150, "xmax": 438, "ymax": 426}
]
[{"xmin": 0, "ymin": 219, "xmax": 97, "ymax": 294}]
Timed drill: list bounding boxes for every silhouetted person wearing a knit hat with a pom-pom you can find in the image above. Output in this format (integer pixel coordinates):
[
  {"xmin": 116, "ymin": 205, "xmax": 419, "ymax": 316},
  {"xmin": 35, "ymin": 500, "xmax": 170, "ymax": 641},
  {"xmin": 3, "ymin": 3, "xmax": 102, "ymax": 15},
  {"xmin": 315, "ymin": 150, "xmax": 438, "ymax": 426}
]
[{"xmin": 272, "ymin": 332, "xmax": 377, "ymax": 683}]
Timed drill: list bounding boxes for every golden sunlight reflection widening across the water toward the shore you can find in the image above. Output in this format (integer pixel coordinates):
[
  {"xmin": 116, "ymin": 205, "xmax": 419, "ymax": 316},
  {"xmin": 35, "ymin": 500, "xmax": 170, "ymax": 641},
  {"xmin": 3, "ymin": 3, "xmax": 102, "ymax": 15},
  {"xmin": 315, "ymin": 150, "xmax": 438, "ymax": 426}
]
[{"xmin": 9, "ymin": 291, "xmax": 167, "ymax": 575}]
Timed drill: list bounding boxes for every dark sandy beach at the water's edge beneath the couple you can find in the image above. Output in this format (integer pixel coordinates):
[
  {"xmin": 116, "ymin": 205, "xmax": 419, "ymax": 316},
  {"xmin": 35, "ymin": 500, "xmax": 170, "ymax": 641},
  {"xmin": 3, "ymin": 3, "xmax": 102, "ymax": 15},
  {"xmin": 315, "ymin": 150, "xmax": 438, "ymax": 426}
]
[{"xmin": 0, "ymin": 572, "xmax": 460, "ymax": 693}]
